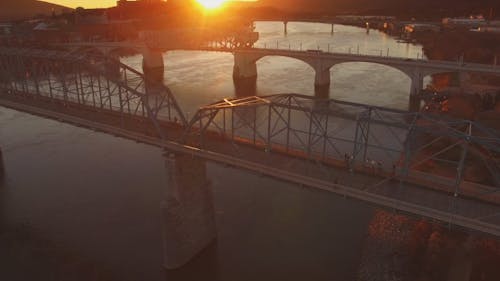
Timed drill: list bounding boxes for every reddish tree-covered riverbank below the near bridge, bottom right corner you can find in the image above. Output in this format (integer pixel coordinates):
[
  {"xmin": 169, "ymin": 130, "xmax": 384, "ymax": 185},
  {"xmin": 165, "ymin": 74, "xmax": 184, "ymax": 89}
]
[{"xmin": 358, "ymin": 210, "xmax": 500, "ymax": 281}]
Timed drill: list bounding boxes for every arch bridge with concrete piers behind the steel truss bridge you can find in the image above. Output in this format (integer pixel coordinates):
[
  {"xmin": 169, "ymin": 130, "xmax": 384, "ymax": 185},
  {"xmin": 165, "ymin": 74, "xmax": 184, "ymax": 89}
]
[{"xmin": 60, "ymin": 37, "xmax": 500, "ymax": 107}]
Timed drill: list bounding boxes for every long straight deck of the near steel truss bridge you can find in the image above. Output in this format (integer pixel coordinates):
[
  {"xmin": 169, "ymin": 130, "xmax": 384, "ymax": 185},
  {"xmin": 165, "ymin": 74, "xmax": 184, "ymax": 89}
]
[{"xmin": 0, "ymin": 93, "xmax": 500, "ymax": 236}]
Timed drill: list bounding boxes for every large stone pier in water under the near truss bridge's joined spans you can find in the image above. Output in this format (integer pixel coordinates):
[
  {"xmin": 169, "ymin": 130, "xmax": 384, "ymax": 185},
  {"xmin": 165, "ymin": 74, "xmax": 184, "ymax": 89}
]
[{"xmin": 161, "ymin": 153, "xmax": 217, "ymax": 269}]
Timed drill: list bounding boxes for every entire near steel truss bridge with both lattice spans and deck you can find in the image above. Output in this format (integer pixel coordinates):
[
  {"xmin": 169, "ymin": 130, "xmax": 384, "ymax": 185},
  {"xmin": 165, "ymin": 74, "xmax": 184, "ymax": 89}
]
[{"xmin": 0, "ymin": 48, "xmax": 500, "ymax": 236}]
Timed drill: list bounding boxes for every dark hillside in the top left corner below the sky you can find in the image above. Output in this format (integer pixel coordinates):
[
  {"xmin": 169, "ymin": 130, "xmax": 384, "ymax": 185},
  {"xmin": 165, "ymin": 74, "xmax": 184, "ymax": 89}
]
[{"xmin": 0, "ymin": 0, "xmax": 70, "ymax": 21}]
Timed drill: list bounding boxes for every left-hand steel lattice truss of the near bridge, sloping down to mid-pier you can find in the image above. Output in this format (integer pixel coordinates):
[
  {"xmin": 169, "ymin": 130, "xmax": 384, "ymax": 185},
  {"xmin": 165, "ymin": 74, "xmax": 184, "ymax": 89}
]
[{"xmin": 0, "ymin": 48, "xmax": 187, "ymax": 138}]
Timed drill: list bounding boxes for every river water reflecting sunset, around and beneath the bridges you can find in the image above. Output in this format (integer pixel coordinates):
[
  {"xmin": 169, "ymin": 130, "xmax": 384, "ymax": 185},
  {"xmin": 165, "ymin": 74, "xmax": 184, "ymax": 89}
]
[{"xmin": 0, "ymin": 22, "xmax": 430, "ymax": 281}]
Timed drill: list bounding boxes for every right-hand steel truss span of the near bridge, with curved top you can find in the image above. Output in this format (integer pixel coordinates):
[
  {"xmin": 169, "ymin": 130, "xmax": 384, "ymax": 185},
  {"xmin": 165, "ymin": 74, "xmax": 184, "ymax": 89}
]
[{"xmin": 184, "ymin": 94, "xmax": 500, "ymax": 234}]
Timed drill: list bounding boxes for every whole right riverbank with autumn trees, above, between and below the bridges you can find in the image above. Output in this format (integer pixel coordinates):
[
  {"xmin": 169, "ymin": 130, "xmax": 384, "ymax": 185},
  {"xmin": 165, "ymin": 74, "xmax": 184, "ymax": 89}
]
[{"xmin": 358, "ymin": 25, "xmax": 500, "ymax": 281}]
